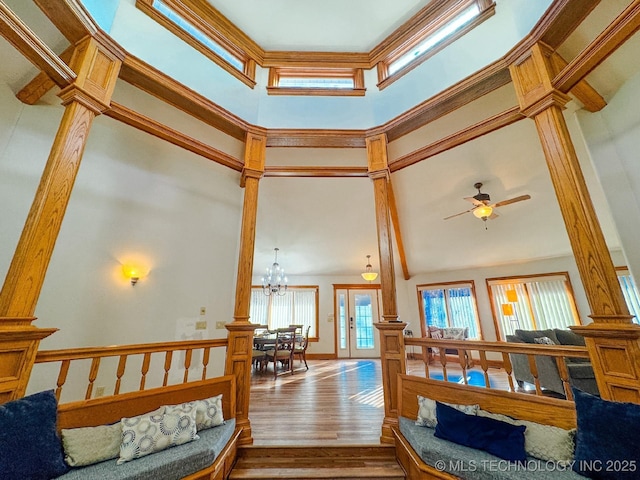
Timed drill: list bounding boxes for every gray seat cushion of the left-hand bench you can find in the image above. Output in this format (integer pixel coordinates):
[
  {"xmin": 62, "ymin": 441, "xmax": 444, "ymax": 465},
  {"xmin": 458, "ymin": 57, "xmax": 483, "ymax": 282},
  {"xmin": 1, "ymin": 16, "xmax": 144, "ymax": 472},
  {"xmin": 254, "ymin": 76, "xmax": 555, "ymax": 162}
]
[{"xmin": 58, "ymin": 419, "xmax": 236, "ymax": 480}]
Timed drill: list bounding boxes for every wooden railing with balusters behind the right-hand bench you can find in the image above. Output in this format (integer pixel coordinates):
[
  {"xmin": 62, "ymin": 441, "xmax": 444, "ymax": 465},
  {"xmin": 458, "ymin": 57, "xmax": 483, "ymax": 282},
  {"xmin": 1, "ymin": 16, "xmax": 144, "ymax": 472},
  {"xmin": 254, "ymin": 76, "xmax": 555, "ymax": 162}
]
[{"xmin": 405, "ymin": 337, "xmax": 589, "ymax": 400}]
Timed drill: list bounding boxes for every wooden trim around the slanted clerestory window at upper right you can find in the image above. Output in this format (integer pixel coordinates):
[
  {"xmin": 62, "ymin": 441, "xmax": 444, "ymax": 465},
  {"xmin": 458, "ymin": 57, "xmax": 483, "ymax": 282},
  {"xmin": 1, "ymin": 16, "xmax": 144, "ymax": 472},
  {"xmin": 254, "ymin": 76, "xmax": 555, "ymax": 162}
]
[{"xmin": 372, "ymin": 0, "xmax": 495, "ymax": 90}]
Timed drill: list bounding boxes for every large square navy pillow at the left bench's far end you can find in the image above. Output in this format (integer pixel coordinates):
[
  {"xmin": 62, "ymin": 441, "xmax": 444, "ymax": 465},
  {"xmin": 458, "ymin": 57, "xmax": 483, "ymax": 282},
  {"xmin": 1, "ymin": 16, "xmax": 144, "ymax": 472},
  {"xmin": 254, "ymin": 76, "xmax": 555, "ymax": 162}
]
[{"xmin": 0, "ymin": 390, "xmax": 67, "ymax": 480}]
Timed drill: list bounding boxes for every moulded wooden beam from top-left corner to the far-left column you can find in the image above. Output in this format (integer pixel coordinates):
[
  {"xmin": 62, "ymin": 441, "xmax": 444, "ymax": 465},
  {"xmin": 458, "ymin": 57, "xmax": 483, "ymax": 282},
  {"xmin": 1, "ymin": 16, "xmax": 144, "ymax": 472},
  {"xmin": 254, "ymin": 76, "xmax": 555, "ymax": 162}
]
[{"xmin": 0, "ymin": 2, "xmax": 76, "ymax": 87}]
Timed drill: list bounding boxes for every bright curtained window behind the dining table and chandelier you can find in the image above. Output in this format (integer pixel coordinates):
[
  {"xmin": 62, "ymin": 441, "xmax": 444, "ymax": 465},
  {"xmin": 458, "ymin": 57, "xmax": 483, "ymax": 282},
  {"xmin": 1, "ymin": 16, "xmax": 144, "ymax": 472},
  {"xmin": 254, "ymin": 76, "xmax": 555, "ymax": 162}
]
[{"xmin": 249, "ymin": 286, "xmax": 318, "ymax": 339}]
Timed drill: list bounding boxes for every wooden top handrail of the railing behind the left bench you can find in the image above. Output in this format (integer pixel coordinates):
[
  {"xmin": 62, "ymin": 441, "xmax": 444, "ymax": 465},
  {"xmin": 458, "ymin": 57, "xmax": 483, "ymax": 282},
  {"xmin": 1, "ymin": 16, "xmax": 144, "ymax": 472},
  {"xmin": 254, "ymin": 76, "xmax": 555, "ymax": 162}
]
[{"xmin": 35, "ymin": 338, "xmax": 227, "ymax": 363}]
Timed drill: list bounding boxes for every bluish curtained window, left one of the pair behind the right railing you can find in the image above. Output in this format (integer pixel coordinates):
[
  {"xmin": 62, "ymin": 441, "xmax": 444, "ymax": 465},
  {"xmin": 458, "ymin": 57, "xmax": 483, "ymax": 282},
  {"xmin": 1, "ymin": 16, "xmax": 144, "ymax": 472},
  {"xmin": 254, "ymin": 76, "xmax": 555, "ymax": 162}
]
[{"xmin": 417, "ymin": 281, "xmax": 481, "ymax": 340}]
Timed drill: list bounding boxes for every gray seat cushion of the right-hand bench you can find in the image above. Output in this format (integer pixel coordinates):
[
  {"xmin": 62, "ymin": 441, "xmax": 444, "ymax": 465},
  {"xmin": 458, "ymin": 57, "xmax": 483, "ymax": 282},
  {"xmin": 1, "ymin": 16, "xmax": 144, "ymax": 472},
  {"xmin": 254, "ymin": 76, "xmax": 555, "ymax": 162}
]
[{"xmin": 399, "ymin": 417, "xmax": 585, "ymax": 480}]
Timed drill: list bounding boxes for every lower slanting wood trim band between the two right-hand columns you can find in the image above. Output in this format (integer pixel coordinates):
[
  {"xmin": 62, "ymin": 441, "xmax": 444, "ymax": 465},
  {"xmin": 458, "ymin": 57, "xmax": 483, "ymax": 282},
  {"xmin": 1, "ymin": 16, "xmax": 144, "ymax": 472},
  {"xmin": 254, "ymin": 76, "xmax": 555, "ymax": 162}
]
[{"xmin": 389, "ymin": 106, "xmax": 526, "ymax": 172}]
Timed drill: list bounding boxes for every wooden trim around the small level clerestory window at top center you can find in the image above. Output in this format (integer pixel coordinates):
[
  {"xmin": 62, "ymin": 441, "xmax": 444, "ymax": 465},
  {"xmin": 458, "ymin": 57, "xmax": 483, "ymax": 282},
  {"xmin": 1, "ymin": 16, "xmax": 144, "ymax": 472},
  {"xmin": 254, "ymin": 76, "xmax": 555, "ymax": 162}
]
[{"xmin": 267, "ymin": 67, "xmax": 366, "ymax": 96}]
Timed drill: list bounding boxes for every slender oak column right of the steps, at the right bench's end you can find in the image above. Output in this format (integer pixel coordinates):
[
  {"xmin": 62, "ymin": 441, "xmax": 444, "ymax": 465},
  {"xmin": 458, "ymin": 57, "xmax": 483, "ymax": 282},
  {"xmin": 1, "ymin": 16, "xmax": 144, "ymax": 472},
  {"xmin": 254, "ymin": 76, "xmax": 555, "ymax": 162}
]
[{"xmin": 367, "ymin": 134, "xmax": 407, "ymax": 443}]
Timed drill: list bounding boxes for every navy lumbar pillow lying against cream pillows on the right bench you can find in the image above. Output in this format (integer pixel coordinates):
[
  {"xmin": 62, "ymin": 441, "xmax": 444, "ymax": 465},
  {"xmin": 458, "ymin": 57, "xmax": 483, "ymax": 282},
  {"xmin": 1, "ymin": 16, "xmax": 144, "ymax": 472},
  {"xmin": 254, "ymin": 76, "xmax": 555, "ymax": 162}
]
[{"xmin": 434, "ymin": 402, "xmax": 527, "ymax": 462}]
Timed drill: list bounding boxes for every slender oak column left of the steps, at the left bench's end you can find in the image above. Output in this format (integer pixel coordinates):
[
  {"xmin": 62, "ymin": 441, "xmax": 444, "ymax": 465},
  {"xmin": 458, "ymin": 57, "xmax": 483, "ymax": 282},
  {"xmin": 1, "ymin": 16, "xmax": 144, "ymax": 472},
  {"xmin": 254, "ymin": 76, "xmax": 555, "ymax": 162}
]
[{"xmin": 225, "ymin": 132, "xmax": 267, "ymax": 445}]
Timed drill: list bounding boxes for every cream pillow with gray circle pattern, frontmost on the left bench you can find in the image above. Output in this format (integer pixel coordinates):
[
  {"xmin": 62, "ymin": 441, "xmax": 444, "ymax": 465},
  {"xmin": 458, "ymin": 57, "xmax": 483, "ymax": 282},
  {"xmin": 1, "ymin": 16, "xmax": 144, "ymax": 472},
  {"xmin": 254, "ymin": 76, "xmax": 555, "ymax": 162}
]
[{"xmin": 117, "ymin": 409, "xmax": 199, "ymax": 465}]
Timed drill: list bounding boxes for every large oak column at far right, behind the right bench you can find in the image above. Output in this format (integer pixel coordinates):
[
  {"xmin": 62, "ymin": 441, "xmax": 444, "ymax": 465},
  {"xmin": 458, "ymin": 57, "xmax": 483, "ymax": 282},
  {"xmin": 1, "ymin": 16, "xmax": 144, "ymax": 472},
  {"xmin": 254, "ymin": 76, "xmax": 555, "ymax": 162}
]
[{"xmin": 510, "ymin": 44, "xmax": 640, "ymax": 403}]
